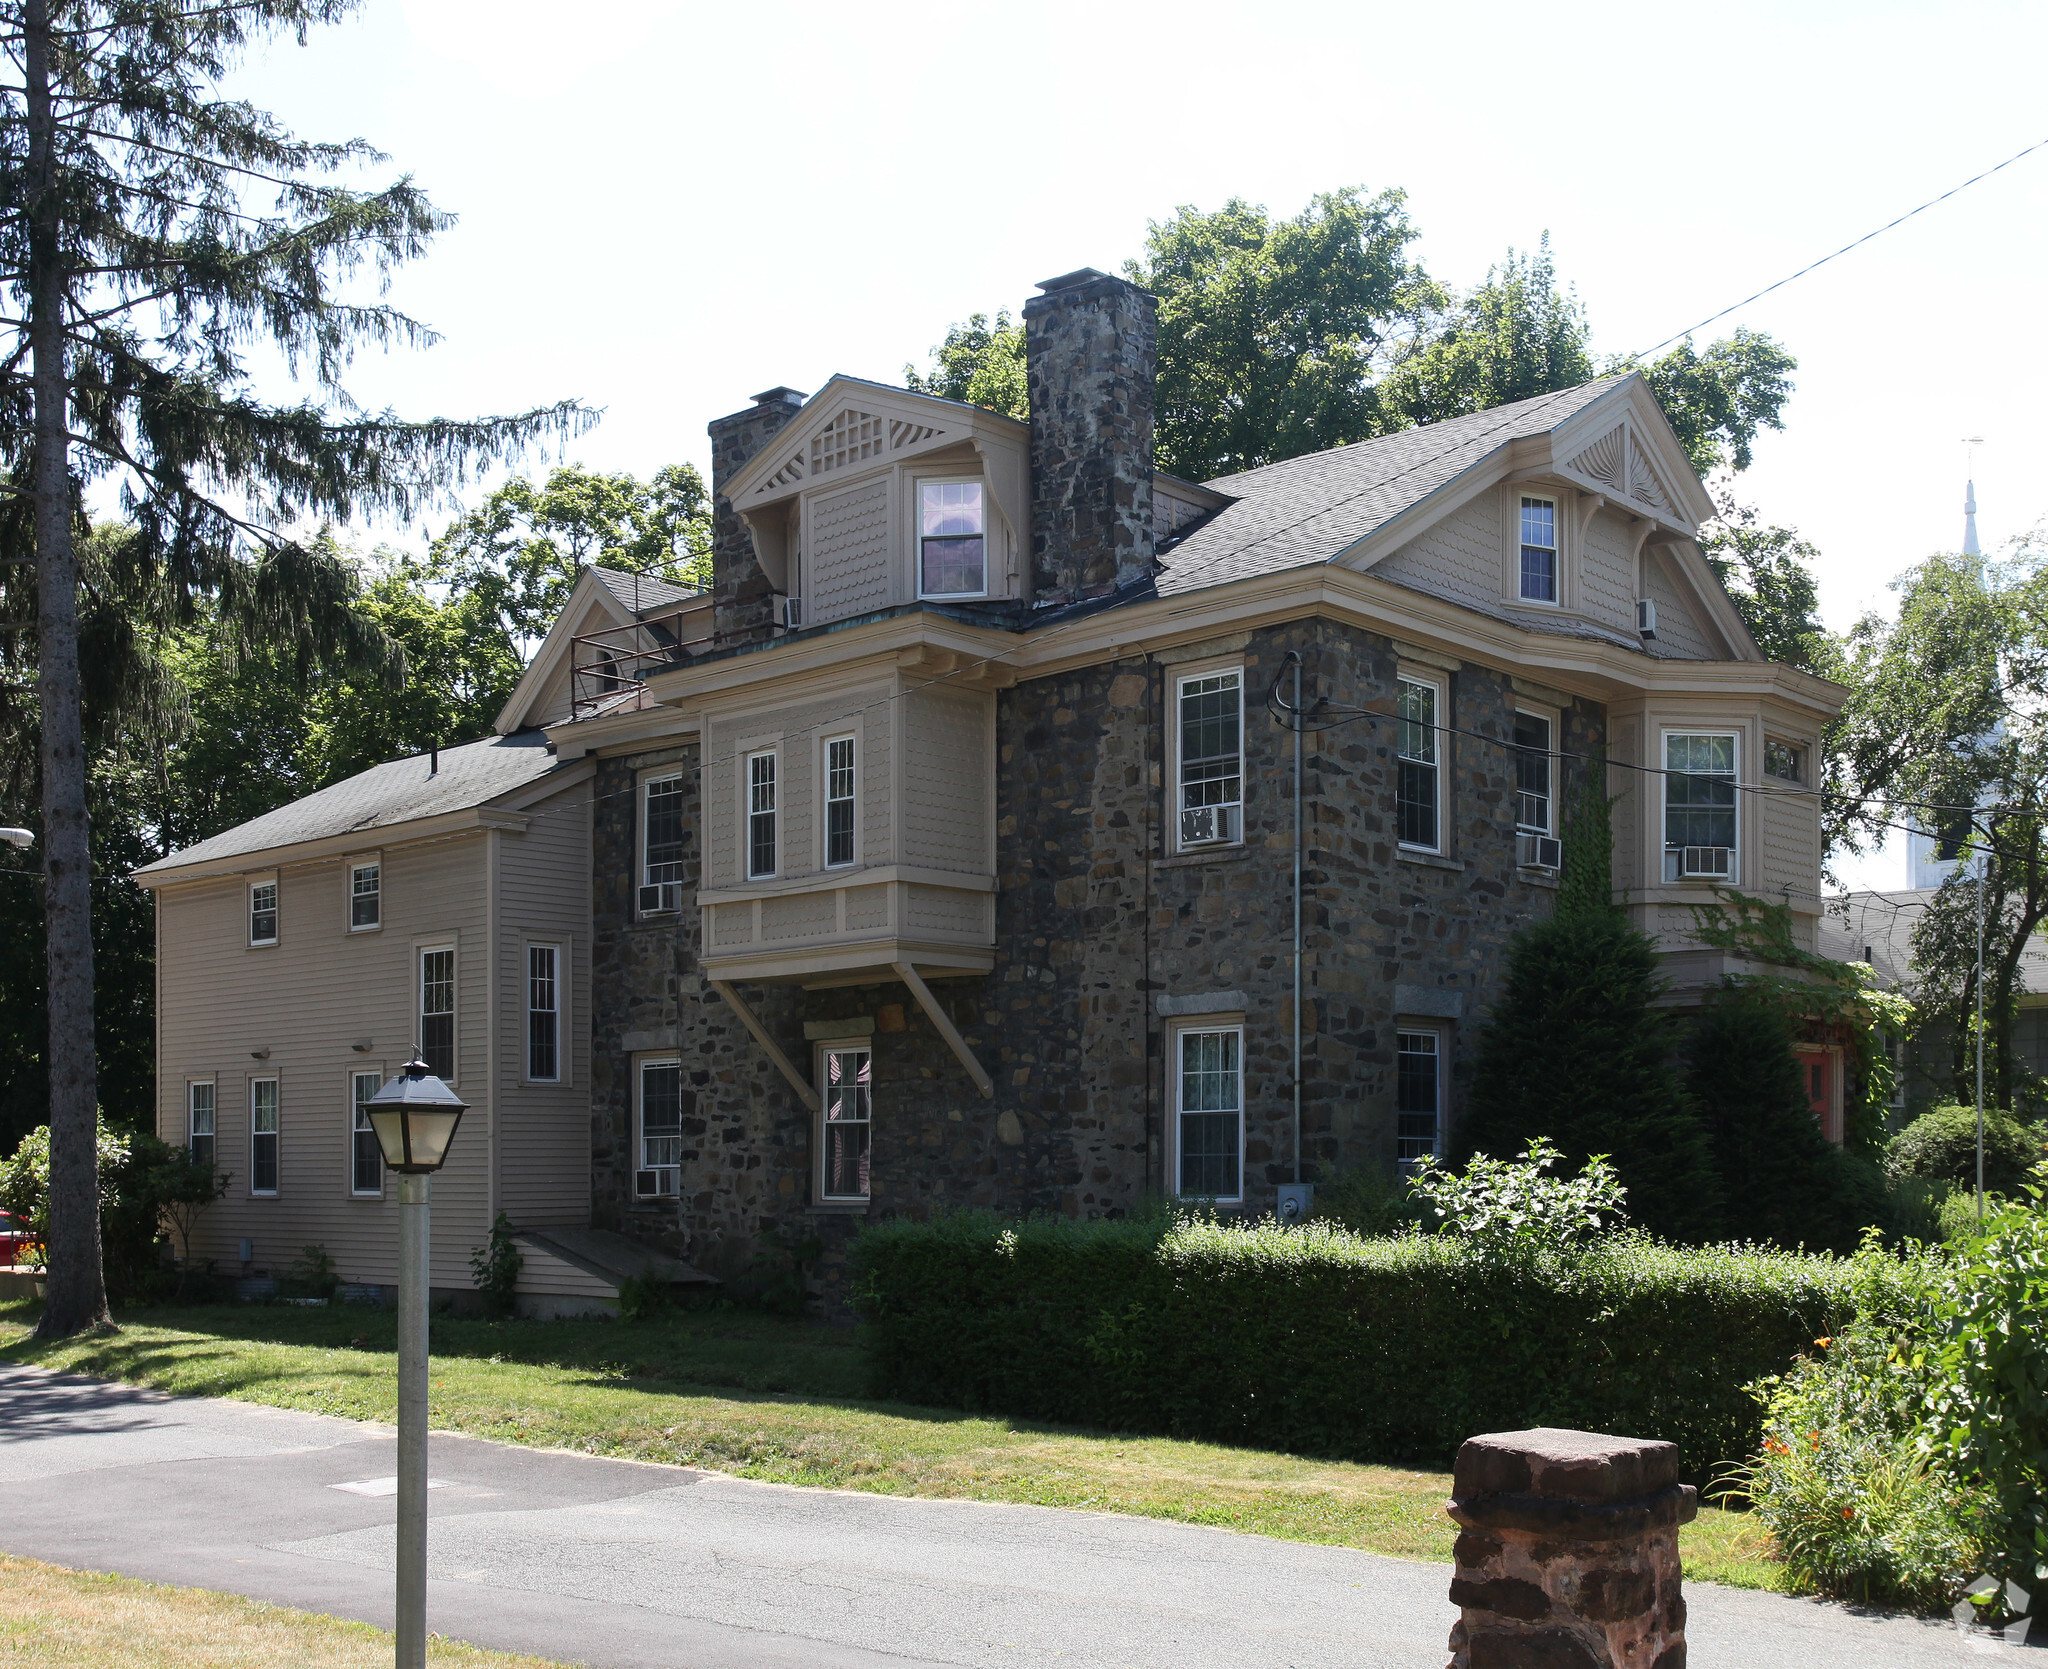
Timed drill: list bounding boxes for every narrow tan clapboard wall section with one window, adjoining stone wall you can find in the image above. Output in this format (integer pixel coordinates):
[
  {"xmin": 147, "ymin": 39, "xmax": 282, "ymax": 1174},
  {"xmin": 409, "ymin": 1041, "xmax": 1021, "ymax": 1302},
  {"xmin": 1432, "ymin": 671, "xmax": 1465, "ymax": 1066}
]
[{"xmin": 498, "ymin": 782, "xmax": 592, "ymax": 1228}]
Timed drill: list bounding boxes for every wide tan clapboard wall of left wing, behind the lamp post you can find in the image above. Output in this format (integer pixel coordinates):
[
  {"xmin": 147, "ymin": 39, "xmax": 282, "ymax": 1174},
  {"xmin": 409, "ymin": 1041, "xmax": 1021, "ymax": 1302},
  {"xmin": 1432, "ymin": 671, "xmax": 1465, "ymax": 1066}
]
[{"xmin": 158, "ymin": 831, "xmax": 492, "ymax": 1286}]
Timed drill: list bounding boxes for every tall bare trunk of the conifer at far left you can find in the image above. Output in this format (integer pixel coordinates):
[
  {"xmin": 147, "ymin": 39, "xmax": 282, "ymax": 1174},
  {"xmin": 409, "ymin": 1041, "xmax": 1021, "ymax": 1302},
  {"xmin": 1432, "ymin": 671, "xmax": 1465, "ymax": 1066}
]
[{"xmin": 23, "ymin": 0, "xmax": 109, "ymax": 1339}]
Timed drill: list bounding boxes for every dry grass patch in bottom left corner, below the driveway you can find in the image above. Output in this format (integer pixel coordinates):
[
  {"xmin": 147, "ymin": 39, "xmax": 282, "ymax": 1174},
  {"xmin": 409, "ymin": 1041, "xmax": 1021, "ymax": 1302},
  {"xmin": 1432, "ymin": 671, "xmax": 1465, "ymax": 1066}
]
[{"xmin": 0, "ymin": 1554, "xmax": 559, "ymax": 1669}]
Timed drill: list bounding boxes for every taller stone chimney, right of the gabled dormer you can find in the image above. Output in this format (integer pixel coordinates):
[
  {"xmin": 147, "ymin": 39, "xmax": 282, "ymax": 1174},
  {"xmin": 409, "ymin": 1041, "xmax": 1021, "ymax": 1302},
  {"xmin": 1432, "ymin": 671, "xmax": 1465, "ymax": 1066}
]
[{"xmin": 1024, "ymin": 266, "xmax": 1159, "ymax": 604}]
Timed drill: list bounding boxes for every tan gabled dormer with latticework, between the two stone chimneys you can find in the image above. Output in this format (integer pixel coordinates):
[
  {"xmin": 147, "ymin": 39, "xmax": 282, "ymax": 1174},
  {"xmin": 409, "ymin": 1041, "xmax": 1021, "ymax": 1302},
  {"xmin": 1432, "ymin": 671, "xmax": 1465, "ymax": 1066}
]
[{"xmin": 725, "ymin": 377, "xmax": 1030, "ymax": 627}]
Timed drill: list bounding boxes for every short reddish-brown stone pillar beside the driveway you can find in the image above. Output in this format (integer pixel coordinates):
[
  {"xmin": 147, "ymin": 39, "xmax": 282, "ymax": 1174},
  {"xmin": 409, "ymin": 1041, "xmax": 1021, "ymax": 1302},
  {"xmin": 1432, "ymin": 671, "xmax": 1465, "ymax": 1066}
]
[{"xmin": 1450, "ymin": 1427, "xmax": 1700, "ymax": 1669}]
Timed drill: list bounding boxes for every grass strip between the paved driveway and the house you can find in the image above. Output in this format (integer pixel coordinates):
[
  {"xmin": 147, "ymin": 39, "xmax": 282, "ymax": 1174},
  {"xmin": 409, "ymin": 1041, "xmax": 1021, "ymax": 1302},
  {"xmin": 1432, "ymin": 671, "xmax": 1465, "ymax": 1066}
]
[{"xmin": 0, "ymin": 1302, "xmax": 1780, "ymax": 1587}]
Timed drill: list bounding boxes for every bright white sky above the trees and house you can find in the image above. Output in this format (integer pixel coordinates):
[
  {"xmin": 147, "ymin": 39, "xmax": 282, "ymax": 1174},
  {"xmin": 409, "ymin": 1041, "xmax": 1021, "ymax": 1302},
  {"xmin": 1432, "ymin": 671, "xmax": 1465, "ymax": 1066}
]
[{"xmin": 224, "ymin": 0, "xmax": 2048, "ymax": 887}]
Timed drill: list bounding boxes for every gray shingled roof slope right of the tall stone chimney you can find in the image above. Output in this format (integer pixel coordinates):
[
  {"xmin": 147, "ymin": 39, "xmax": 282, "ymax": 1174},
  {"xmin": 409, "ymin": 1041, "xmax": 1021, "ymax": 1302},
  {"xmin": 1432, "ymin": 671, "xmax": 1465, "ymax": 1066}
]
[{"xmin": 1159, "ymin": 373, "xmax": 1632, "ymax": 596}]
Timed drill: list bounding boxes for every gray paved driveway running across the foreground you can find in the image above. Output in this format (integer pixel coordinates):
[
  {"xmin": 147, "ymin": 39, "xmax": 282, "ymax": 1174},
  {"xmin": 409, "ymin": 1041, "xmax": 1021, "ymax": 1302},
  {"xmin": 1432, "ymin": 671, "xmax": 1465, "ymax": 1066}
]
[{"xmin": 0, "ymin": 1364, "xmax": 2023, "ymax": 1669}]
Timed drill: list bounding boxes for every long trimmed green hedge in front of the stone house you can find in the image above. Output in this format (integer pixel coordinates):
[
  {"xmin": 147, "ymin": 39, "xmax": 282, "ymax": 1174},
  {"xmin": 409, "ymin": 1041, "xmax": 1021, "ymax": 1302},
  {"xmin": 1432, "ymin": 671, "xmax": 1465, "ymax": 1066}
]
[{"xmin": 854, "ymin": 1212, "xmax": 1884, "ymax": 1479}]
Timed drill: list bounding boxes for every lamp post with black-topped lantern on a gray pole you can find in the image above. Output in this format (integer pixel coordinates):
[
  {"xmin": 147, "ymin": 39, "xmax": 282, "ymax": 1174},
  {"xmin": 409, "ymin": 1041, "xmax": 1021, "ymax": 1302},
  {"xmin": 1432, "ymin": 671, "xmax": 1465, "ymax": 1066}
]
[{"xmin": 365, "ymin": 1057, "xmax": 467, "ymax": 1669}]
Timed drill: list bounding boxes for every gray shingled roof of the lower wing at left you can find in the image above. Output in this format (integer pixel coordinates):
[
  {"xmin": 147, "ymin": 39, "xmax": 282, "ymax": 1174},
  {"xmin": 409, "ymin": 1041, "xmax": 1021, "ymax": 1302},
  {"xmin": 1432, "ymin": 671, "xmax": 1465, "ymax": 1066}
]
[{"xmin": 135, "ymin": 731, "xmax": 557, "ymax": 874}]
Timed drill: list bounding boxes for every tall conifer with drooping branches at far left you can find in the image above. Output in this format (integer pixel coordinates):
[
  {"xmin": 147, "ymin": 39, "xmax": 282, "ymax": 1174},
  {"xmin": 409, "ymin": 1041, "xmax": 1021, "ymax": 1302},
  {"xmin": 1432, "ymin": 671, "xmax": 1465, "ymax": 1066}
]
[{"xmin": 0, "ymin": 0, "xmax": 584, "ymax": 1337}]
